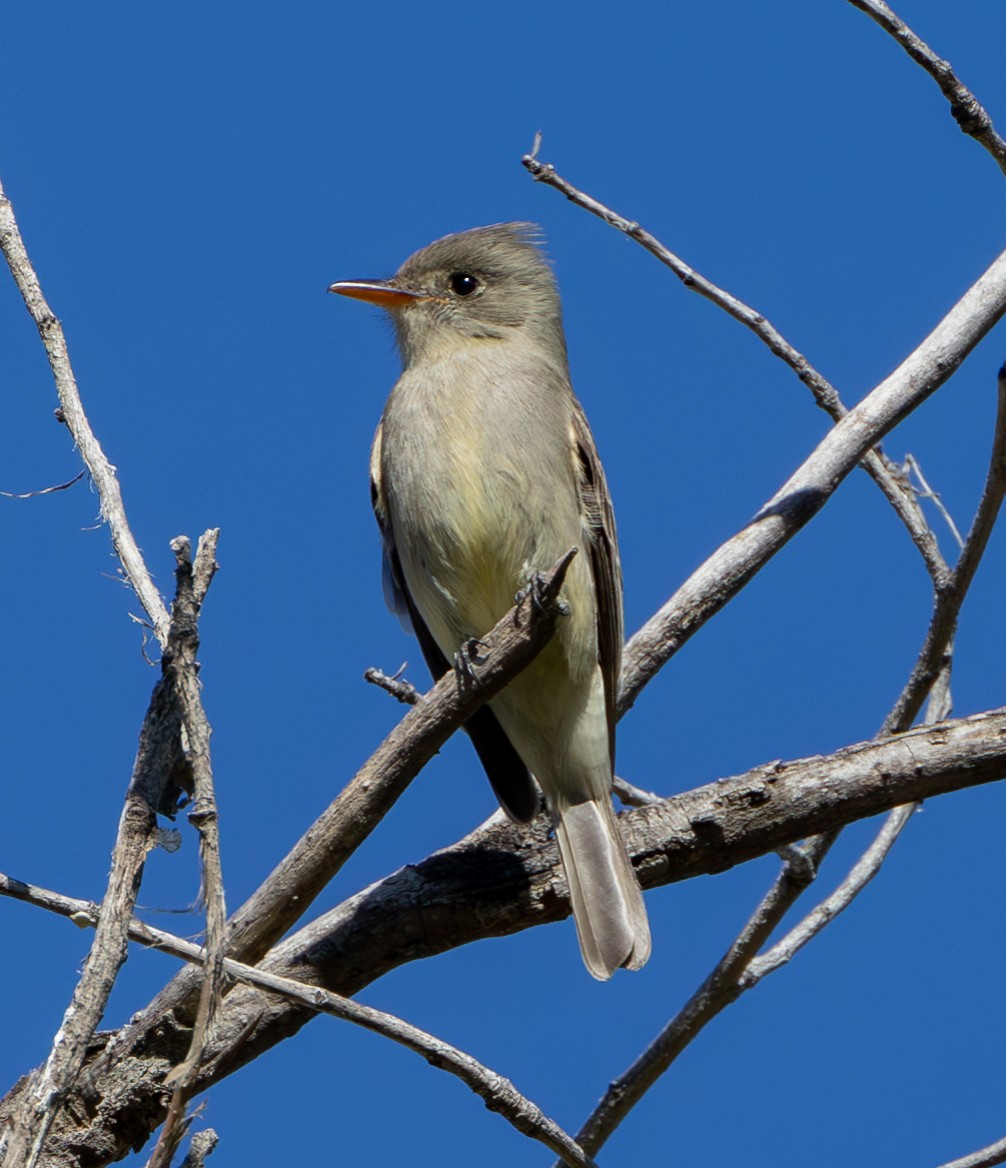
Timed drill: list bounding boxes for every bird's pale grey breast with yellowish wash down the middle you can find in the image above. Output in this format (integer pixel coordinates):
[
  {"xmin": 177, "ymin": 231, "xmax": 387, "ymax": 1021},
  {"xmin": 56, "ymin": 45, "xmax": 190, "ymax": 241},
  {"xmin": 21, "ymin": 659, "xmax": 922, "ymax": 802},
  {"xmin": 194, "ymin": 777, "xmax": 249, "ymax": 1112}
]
[{"xmin": 381, "ymin": 345, "xmax": 582, "ymax": 651}]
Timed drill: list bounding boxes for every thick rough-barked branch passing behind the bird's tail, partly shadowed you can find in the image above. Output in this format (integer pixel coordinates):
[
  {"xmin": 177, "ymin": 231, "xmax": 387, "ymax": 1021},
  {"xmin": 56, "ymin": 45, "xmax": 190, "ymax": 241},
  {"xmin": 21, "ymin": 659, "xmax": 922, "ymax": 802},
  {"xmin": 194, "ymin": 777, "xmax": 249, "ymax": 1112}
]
[{"xmin": 7, "ymin": 710, "xmax": 1006, "ymax": 1168}]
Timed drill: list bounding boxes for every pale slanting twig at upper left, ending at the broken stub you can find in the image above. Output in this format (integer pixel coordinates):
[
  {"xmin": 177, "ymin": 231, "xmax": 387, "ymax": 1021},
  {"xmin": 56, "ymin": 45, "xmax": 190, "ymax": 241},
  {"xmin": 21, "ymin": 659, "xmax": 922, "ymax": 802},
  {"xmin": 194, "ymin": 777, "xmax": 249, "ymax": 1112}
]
[{"xmin": 0, "ymin": 177, "xmax": 168, "ymax": 646}]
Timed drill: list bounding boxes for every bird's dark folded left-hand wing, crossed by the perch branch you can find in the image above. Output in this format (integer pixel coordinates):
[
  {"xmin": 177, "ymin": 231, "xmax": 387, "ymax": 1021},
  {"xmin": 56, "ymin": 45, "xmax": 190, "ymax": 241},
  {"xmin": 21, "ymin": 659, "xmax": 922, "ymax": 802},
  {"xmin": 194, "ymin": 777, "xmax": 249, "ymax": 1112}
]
[{"xmin": 370, "ymin": 425, "xmax": 540, "ymax": 823}]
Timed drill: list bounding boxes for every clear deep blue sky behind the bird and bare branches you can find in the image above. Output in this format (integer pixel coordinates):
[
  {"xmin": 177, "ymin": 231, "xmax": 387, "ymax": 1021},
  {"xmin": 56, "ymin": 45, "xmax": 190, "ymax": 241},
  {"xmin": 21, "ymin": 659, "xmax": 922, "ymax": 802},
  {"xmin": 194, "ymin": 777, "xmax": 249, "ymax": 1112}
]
[{"xmin": 0, "ymin": 0, "xmax": 1006, "ymax": 1168}]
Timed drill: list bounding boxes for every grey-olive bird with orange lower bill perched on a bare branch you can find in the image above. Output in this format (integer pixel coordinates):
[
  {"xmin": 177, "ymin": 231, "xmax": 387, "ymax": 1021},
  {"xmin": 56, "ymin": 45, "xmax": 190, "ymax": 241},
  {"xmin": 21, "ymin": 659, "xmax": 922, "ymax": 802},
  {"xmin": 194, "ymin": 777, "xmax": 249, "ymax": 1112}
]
[{"xmin": 328, "ymin": 223, "xmax": 650, "ymax": 979}]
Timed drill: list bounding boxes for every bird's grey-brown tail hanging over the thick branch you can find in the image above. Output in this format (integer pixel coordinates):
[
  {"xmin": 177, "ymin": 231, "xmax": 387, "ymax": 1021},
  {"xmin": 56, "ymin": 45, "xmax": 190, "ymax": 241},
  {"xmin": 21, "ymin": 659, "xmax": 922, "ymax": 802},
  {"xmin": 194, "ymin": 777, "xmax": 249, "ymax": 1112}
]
[{"xmin": 555, "ymin": 798, "xmax": 650, "ymax": 981}]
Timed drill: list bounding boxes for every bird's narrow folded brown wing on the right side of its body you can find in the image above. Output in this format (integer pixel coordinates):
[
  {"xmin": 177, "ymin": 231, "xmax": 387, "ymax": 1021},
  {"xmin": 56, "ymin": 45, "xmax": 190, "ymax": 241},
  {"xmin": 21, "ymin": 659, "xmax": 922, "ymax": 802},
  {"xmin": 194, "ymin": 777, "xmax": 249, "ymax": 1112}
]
[{"xmin": 571, "ymin": 399, "xmax": 623, "ymax": 767}]
